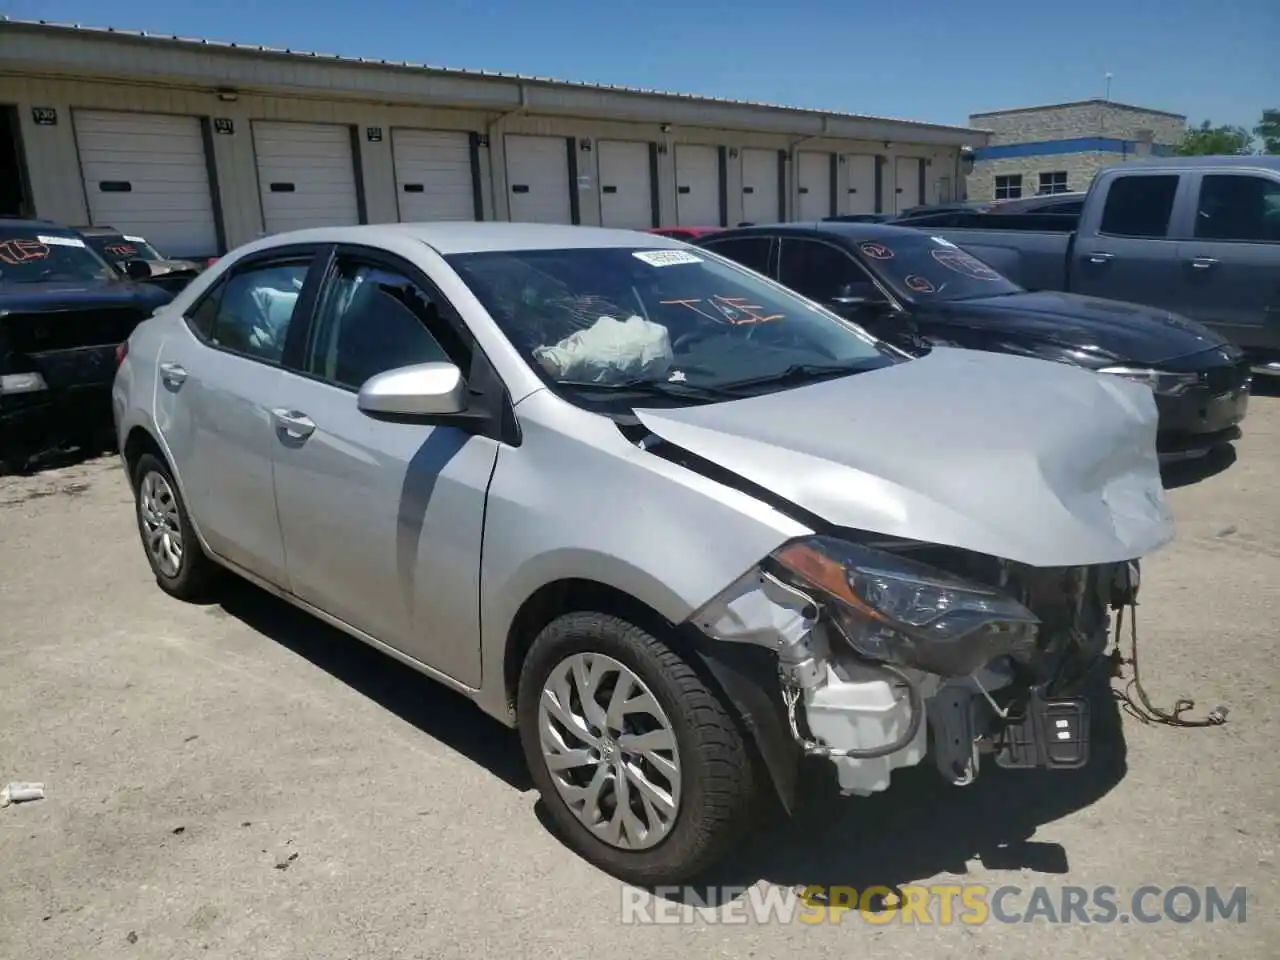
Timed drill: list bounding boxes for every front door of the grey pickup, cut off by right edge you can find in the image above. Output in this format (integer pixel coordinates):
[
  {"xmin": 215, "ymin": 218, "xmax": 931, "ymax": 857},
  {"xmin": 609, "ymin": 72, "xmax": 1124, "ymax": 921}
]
[{"xmin": 1178, "ymin": 170, "xmax": 1280, "ymax": 349}]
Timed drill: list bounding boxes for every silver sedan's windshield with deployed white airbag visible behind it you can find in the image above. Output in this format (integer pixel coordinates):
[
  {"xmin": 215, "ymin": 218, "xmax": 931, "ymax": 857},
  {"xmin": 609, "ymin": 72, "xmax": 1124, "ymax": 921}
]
[{"xmin": 448, "ymin": 247, "xmax": 902, "ymax": 408}]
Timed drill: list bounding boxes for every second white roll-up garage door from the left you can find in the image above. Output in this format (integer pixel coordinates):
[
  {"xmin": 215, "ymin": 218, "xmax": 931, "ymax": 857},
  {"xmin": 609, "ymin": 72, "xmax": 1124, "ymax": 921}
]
[{"xmin": 253, "ymin": 120, "xmax": 360, "ymax": 233}]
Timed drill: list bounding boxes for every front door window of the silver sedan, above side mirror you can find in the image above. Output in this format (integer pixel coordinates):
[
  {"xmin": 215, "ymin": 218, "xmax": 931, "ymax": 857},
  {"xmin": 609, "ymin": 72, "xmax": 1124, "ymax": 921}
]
[{"xmin": 303, "ymin": 259, "xmax": 467, "ymax": 390}]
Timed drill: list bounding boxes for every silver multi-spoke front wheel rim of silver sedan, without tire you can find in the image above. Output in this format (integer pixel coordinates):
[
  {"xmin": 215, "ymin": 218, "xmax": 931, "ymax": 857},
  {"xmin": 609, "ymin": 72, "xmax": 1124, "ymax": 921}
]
[{"xmin": 538, "ymin": 653, "xmax": 681, "ymax": 850}]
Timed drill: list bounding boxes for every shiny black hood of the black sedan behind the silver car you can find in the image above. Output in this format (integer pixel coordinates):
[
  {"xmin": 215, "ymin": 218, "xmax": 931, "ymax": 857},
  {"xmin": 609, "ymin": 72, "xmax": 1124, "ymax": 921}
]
[{"xmin": 929, "ymin": 291, "xmax": 1226, "ymax": 364}]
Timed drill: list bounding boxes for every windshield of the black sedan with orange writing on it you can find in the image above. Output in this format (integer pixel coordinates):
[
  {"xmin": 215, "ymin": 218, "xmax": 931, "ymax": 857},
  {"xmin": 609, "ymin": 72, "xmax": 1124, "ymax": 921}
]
[{"xmin": 855, "ymin": 230, "xmax": 1023, "ymax": 303}]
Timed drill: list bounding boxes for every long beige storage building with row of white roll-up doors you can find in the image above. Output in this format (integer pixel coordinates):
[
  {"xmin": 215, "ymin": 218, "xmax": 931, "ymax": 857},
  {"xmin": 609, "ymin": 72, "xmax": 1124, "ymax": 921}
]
[{"xmin": 0, "ymin": 20, "xmax": 986, "ymax": 256}]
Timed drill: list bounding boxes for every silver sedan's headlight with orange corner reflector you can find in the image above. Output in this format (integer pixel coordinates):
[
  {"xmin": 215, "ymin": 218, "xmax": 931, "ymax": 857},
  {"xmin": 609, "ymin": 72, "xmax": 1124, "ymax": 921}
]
[{"xmin": 773, "ymin": 536, "xmax": 1039, "ymax": 677}]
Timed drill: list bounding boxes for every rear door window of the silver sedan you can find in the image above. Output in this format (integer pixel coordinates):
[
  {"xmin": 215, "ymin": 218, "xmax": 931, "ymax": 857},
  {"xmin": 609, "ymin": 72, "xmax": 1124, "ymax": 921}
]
[{"xmin": 203, "ymin": 257, "xmax": 311, "ymax": 364}]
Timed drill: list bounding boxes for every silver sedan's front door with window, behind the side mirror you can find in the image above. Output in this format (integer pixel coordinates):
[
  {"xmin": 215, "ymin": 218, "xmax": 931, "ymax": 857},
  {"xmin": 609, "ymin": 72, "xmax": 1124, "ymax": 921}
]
[{"xmin": 274, "ymin": 248, "xmax": 498, "ymax": 686}]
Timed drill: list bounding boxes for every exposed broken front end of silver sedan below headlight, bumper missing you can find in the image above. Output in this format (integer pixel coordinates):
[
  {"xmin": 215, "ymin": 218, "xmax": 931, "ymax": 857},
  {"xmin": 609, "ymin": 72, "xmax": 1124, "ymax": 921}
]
[{"xmin": 692, "ymin": 548, "xmax": 1138, "ymax": 806}]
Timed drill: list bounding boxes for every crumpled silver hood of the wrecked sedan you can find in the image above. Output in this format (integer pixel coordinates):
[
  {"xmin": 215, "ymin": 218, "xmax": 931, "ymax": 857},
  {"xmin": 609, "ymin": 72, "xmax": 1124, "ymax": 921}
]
[{"xmin": 636, "ymin": 348, "xmax": 1174, "ymax": 567}]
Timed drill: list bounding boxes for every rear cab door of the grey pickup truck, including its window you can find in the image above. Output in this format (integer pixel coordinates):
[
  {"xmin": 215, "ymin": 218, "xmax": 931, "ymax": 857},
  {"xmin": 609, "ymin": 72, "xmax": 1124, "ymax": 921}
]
[{"xmin": 1070, "ymin": 170, "xmax": 1190, "ymax": 311}]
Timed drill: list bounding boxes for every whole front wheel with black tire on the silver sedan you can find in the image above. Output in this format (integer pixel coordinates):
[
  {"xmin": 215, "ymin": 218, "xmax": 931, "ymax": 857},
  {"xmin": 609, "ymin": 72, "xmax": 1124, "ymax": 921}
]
[{"xmin": 517, "ymin": 613, "xmax": 756, "ymax": 886}]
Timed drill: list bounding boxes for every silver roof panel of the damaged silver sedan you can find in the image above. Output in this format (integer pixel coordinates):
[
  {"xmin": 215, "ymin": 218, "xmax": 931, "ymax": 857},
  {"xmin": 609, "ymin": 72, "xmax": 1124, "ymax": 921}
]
[{"xmin": 238, "ymin": 220, "xmax": 687, "ymax": 255}]
